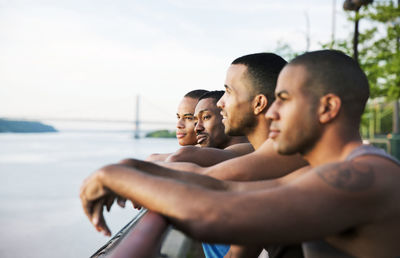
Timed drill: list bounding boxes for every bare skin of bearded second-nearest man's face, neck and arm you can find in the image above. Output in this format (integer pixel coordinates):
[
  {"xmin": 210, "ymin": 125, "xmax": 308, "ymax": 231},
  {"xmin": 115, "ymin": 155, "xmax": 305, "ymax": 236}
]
[{"xmin": 156, "ymin": 64, "xmax": 307, "ymax": 181}]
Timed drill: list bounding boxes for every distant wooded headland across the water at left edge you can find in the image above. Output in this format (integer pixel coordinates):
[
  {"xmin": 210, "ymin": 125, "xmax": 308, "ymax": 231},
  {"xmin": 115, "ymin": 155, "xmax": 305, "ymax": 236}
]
[{"xmin": 0, "ymin": 118, "xmax": 58, "ymax": 133}]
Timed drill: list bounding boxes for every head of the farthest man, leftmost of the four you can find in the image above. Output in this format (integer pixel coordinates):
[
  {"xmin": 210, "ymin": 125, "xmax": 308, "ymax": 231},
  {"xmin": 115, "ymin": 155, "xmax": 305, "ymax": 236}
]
[{"xmin": 176, "ymin": 90, "xmax": 208, "ymax": 146}]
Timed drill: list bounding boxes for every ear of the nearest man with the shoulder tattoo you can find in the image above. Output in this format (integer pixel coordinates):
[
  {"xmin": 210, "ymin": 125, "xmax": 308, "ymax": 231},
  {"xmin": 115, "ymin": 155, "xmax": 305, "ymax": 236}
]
[{"xmin": 318, "ymin": 93, "xmax": 342, "ymax": 124}]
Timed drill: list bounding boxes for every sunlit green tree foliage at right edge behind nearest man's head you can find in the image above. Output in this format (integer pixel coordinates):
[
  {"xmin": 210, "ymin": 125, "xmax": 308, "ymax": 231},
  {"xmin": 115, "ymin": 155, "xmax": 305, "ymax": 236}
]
[{"xmin": 323, "ymin": 1, "xmax": 400, "ymax": 138}]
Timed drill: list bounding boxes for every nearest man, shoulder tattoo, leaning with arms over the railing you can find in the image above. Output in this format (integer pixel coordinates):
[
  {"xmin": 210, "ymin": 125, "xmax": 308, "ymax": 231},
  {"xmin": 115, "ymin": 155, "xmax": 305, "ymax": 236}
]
[{"xmin": 81, "ymin": 50, "xmax": 400, "ymax": 257}]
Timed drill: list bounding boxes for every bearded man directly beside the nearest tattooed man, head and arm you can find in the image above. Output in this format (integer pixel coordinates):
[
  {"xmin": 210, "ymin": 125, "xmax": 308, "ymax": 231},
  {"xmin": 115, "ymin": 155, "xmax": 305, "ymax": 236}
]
[{"xmin": 158, "ymin": 53, "xmax": 306, "ymax": 181}]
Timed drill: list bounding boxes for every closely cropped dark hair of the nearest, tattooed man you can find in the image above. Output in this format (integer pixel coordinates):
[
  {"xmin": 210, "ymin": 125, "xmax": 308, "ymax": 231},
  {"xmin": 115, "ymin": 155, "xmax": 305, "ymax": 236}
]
[{"xmin": 289, "ymin": 50, "xmax": 369, "ymax": 124}]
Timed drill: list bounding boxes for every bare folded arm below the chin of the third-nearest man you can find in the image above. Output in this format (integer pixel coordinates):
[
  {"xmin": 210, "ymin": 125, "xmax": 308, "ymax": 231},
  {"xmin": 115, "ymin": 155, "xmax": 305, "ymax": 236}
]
[{"xmin": 165, "ymin": 143, "xmax": 254, "ymax": 167}]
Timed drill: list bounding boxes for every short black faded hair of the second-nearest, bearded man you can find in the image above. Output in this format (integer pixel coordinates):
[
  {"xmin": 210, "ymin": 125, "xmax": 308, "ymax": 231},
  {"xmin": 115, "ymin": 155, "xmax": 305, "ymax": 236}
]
[{"xmin": 232, "ymin": 53, "xmax": 287, "ymax": 106}]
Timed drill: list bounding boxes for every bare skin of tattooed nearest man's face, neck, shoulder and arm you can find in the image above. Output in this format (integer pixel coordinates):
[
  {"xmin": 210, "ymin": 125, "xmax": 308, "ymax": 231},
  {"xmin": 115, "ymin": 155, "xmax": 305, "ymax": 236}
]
[{"xmin": 81, "ymin": 63, "xmax": 400, "ymax": 257}]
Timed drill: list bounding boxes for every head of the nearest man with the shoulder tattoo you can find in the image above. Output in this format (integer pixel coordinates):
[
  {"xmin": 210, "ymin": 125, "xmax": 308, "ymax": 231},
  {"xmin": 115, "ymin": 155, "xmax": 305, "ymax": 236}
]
[{"xmin": 267, "ymin": 50, "xmax": 369, "ymax": 154}]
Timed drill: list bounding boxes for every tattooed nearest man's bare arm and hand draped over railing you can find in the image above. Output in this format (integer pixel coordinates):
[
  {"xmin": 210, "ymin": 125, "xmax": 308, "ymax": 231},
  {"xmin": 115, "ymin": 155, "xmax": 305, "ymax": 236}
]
[{"xmin": 81, "ymin": 157, "xmax": 386, "ymax": 245}]
